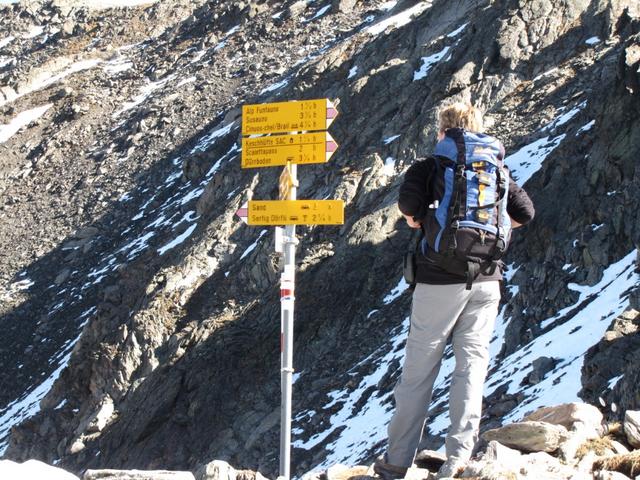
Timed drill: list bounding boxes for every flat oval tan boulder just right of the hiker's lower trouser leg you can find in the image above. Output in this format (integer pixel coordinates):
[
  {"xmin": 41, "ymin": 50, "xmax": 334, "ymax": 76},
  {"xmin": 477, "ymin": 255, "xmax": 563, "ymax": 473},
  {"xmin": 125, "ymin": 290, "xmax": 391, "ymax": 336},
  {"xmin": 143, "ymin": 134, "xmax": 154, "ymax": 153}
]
[{"xmin": 482, "ymin": 421, "xmax": 569, "ymax": 452}]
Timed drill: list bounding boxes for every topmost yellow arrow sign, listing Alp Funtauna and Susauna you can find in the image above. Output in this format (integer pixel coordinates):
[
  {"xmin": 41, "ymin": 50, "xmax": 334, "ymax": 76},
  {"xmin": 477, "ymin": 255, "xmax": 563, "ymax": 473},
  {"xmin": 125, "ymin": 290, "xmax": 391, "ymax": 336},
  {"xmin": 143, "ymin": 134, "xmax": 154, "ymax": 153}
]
[{"xmin": 242, "ymin": 98, "xmax": 338, "ymax": 135}]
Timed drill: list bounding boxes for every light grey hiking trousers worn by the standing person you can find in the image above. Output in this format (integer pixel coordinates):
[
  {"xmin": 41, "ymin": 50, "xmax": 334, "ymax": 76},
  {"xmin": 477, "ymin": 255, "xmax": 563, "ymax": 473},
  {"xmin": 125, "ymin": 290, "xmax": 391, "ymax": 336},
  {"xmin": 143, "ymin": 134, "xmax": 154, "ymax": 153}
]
[{"xmin": 387, "ymin": 281, "xmax": 500, "ymax": 467}]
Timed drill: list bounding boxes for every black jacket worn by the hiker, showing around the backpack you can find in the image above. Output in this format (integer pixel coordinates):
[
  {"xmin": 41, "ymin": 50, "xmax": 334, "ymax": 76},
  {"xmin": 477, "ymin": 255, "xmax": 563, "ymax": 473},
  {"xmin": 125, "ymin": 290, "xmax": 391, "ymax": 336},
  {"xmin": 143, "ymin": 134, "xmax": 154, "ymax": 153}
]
[{"xmin": 398, "ymin": 157, "xmax": 535, "ymax": 285}]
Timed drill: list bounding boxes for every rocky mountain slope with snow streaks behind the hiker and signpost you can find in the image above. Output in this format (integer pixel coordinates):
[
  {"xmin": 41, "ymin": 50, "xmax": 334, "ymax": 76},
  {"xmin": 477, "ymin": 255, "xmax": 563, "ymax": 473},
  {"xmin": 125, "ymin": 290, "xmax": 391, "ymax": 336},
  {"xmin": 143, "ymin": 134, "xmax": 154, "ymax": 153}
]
[{"xmin": 0, "ymin": 0, "xmax": 640, "ymax": 476}]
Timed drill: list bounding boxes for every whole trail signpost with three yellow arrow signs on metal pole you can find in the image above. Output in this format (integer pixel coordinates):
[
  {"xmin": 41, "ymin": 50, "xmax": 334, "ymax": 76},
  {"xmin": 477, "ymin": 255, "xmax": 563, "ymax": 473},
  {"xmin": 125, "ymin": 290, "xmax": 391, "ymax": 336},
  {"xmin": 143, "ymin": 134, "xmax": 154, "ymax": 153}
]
[{"xmin": 236, "ymin": 98, "xmax": 344, "ymax": 480}]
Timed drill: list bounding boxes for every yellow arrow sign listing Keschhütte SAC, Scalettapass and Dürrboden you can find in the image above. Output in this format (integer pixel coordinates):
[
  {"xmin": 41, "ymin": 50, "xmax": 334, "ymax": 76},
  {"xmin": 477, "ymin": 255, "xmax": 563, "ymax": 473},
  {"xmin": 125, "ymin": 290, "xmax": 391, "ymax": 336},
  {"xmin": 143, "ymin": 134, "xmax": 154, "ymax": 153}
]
[{"xmin": 241, "ymin": 132, "xmax": 338, "ymax": 168}]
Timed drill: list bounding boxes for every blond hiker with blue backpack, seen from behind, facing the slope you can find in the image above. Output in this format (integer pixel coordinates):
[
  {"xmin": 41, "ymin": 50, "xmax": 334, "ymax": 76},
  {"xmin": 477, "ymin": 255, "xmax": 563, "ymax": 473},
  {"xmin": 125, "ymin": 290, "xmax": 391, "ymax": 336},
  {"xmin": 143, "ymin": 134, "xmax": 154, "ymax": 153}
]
[{"xmin": 374, "ymin": 103, "xmax": 534, "ymax": 480}]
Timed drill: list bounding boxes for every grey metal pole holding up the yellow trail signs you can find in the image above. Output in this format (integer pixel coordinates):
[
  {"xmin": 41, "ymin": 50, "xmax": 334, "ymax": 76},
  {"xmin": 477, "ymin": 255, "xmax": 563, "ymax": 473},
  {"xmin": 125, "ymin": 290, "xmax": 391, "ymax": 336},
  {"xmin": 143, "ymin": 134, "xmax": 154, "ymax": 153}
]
[{"xmin": 280, "ymin": 164, "xmax": 297, "ymax": 480}]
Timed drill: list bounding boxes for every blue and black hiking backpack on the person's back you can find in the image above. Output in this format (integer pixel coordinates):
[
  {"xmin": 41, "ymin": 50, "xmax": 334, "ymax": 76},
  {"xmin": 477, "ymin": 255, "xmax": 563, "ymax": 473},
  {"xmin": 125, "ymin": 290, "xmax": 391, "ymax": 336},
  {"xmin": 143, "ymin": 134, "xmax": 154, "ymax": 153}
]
[{"xmin": 422, "ymin": 128, "xmax": 511, "ymax": 289}]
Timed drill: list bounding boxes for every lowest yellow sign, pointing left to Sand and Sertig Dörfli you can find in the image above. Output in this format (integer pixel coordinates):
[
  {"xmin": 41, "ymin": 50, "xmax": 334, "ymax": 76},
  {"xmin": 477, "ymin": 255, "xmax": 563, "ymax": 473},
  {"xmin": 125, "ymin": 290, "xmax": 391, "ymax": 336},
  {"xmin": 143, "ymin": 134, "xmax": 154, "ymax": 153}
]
[{"xmin": 245, "ymin": 200, "xmax": 344, "ymax": 225}]
